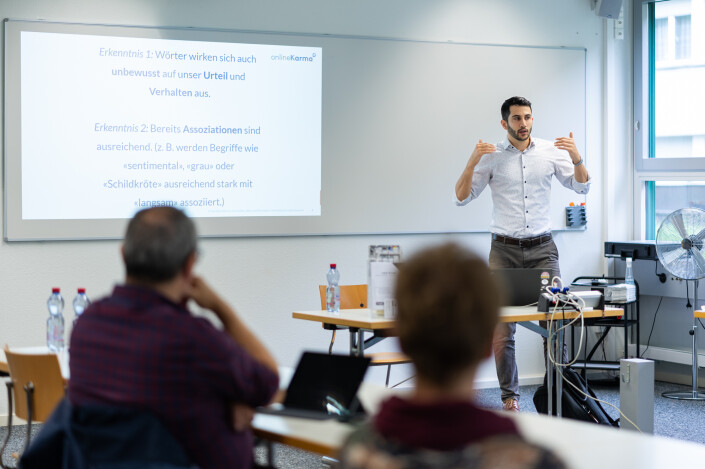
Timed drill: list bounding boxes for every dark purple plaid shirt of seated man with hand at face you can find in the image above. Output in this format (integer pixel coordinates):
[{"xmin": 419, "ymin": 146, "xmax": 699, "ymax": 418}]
[{"xmin": 69, "ymin": 286, "xmax": 278, "ymax": 469}]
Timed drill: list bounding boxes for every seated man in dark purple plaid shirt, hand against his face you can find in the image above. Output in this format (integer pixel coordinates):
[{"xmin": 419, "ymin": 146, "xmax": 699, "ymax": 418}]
[{"xmin": 68, "ymin": 207, "xmax": 279, "ymax": 468}]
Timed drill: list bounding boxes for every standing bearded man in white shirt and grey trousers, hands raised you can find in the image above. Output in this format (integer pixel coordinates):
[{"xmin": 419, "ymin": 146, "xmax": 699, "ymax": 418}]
[{"xmin": 455, "ymin": 96, "xmax": 590, "ymax": 411}]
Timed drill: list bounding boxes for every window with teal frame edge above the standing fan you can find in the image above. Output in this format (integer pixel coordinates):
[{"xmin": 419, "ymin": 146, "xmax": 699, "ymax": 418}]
[{"xmin": 634, "ymin": 0, "xmax": 705, "ymax": 239}]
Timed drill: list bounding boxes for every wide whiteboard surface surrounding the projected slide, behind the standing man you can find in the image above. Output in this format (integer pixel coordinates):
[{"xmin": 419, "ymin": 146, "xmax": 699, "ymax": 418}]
[{"xmin": 4, "ymin": 21, "xmax": 589, "ymax": 240}]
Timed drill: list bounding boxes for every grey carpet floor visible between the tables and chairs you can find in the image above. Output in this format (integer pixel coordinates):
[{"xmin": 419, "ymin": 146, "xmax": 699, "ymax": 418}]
[{"xmin": 0, "ymin": 380, "xmax": 705, "ymax": 469}]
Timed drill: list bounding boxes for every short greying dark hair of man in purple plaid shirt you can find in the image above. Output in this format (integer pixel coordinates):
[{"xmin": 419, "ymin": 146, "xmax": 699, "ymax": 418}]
[{"xmin": 123, "ymin": 207, "xmax": 197, "ymax": 282}]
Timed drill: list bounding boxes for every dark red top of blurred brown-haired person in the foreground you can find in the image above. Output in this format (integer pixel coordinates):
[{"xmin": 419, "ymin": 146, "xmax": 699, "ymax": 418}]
[{"xmin": 339, "ymin": 396, "xmax": 566, "ymax": 469}]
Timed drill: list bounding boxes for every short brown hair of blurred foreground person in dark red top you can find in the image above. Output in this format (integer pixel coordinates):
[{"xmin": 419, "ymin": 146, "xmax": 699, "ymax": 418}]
[{"xmin": 395, "ymin": 243, "xmax": 500, "ymax": 386}]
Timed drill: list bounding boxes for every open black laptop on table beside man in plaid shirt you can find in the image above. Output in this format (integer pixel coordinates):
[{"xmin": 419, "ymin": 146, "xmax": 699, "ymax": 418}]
[{"xmin": 257, "ymin": 352, "xmax": 370, "ymax": 420}]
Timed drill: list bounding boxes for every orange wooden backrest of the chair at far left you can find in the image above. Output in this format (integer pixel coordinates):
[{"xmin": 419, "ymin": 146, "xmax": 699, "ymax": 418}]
[{"xmin": 5, "ymin": 346, "xmax": 66, "ymax": 422}]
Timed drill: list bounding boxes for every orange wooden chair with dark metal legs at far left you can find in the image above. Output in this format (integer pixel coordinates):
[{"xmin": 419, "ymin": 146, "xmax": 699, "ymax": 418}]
[{"xmin": 0, "ymin": 345, "xmax": 66, "ymax": 468}]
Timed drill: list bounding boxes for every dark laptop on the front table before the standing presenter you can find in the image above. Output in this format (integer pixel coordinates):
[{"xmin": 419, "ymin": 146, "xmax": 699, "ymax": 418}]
[{"xmin": 492, "ymin": 268, "xmax": 553, "ymax": 306}]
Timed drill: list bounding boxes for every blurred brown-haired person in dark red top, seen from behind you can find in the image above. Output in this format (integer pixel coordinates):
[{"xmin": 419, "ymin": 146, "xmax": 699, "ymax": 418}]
[{"xmin": 341, "ymin": 244, "xmax": 564, "ymax": 469}]
